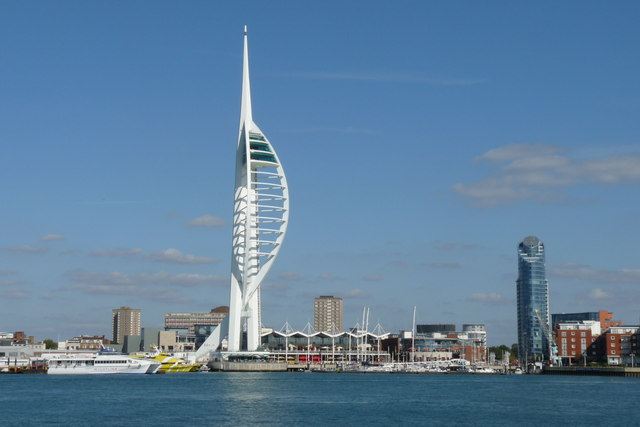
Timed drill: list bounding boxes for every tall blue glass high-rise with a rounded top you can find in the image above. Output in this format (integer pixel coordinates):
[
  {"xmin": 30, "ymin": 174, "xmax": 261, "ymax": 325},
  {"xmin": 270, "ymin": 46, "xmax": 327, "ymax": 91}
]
[{"xmin": 516, "ymin": 236, "xmax": 551, "ymax": 361}]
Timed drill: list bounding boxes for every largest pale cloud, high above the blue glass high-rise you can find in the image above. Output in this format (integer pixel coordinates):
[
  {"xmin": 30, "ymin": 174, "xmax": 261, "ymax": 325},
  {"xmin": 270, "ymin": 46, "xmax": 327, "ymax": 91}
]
[{"xmin": 451, "ymin": 144, "xmax": 640, "ymax": 207}]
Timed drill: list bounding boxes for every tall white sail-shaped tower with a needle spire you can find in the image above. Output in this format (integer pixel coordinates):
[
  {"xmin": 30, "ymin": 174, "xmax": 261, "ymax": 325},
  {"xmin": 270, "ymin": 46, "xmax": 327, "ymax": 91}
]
[{"xmin": 227, "ymin": 26, "xmax": 289, "ymax": 352}]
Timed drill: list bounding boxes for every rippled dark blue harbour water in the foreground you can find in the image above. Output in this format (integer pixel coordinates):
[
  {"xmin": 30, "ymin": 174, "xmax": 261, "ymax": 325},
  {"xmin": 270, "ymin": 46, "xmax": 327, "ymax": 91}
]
[{"xmin": 0, "ymin": 373, "xmax": 640, "ymax": 426}]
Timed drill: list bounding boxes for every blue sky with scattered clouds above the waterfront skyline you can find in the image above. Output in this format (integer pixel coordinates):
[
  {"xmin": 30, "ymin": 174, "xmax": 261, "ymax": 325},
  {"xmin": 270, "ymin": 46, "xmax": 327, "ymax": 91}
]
[{"xmin": 0, "ymin": 1, "xmax": 640, "ymax": 344}]
